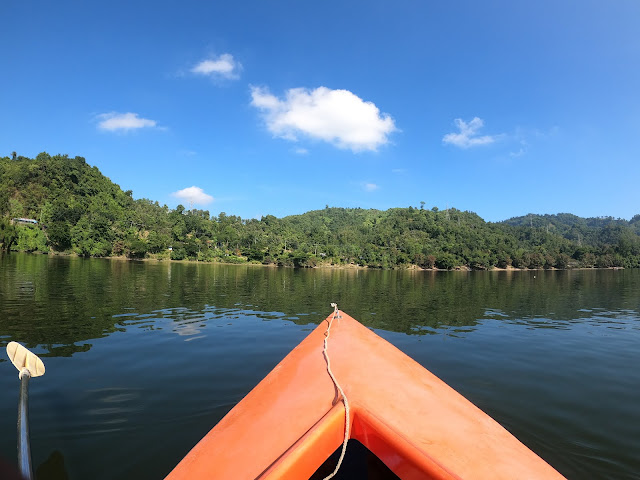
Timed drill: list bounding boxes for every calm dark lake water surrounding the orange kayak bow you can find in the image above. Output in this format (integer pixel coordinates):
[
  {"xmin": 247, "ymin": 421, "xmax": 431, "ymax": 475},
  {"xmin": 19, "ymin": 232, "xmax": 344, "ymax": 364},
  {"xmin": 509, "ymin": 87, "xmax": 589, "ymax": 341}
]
[{"xmin": 0, "ymin": 254, "xmax": 640, "ymax": 479}]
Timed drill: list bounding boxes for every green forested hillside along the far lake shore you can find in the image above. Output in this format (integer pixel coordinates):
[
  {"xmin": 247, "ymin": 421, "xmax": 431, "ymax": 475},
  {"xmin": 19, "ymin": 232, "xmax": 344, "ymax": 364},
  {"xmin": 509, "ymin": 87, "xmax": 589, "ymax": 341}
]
[{"xmin": 0, "ymin": 153, "xmax": 640, "ymax": 269}]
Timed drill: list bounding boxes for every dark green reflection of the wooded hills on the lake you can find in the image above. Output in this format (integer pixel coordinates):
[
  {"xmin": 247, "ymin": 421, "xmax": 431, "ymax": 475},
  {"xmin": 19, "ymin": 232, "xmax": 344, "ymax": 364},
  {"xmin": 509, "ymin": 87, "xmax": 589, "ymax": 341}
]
[{"xmin": 0, "ymin": 254, "xmax": 640, "ymax": 356}]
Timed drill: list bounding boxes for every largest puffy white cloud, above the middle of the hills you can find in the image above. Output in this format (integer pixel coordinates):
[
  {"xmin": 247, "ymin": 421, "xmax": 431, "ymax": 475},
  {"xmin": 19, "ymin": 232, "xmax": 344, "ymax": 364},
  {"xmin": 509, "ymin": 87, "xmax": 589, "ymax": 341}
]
[{"xmin": 251, "ymin": 87, "xmax": 397, "ymax": 152}]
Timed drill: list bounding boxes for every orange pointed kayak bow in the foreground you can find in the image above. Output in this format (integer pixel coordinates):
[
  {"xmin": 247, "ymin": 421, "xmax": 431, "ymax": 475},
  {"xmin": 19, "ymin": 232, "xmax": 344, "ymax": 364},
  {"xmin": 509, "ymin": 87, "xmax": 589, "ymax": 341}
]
[{"xmin": 167, "ymin": 311, "xmax": 564, "ymax": 480}]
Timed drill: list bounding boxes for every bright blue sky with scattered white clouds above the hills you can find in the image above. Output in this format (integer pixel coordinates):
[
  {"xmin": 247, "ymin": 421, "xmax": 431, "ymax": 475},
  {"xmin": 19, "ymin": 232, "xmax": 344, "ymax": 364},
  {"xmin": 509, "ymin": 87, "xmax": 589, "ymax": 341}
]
[{"xmin": 0, "ymin": 0, "xmax": 640, "ymax": 221}]
